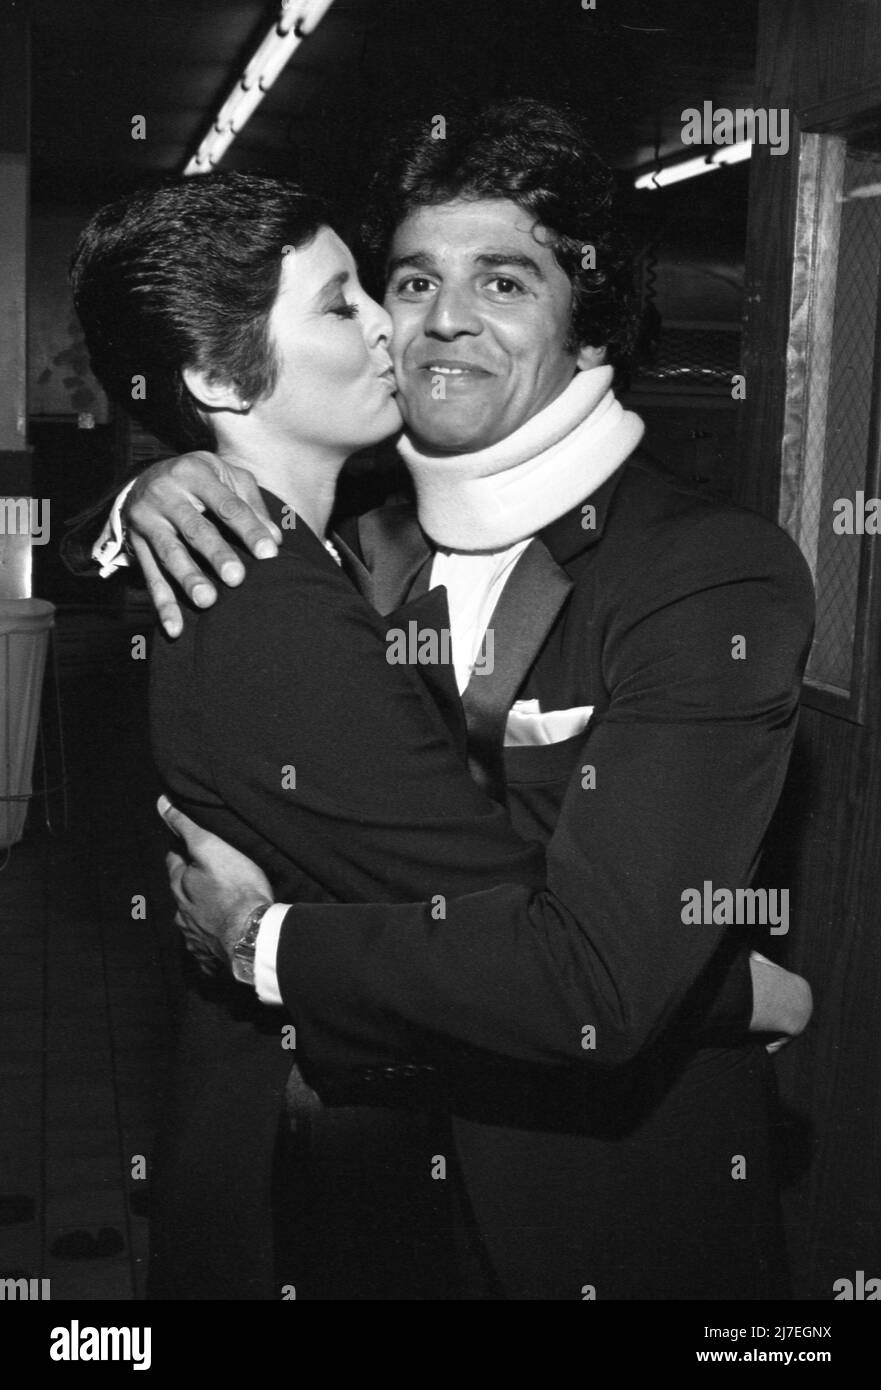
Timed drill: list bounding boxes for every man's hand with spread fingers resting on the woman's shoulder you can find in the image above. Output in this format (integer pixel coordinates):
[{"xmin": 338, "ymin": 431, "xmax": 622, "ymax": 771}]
[{"xmin": 122, "ymin": 452, "xmax": 282, "ymax": 637}]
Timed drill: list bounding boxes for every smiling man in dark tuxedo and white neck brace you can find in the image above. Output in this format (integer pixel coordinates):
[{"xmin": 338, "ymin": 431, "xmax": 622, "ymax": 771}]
[{"xmin": 88, "ymin": 103, "xmax": 812, "ymax": 1300}]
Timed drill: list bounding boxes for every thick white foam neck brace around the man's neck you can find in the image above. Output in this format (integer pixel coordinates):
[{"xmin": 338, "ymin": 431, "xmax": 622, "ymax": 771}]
[{"xmin": 397, "ymin": 367, "xmax": 645, "ymax": 550}]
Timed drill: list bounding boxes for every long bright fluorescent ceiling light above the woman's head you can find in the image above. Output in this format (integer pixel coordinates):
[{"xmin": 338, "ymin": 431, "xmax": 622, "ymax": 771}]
[{"xmin": 183, "ymin": 0, "xmax": 334, "ymax": 175}]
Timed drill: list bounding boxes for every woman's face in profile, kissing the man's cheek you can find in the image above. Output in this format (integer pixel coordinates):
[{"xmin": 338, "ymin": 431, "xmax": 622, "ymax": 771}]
[{"xmin": 252, "ymin": 227, "xmax": 400, "ymax": 453}]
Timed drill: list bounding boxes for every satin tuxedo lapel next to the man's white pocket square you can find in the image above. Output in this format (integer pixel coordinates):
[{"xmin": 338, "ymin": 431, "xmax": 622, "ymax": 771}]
[{"xmin": 463, "ymin": 538, "xmax": 573, "ymax": 803}]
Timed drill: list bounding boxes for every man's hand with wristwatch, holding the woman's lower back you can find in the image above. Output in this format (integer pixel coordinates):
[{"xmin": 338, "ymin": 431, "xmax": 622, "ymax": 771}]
[{"xmin": 157, "ymin": 796, "xmax": 272, "ymax": 967}]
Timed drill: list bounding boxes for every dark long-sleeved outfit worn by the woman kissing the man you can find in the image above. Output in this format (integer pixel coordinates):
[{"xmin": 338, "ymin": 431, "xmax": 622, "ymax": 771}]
[{"xmin": 150, "ymin": 493, "xmax": 545, "ymax": 1298}]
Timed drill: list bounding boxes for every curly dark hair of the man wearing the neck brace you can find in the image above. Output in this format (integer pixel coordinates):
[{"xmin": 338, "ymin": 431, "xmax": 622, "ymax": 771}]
[{"xmin": 360, "ymin": 97, "xmax": 636, "ymax": 366}]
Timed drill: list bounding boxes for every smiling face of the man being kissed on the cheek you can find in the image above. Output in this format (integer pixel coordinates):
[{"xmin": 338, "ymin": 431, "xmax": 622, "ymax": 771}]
[{"xmin": 385, "ymin": 199, "xmax": 603, "ymax": 453}]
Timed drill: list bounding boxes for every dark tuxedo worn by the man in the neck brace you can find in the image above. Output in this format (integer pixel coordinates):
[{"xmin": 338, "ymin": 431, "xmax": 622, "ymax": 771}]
[{"xmin": 270, "ymin": 456, "xmax": 813, "ymax": 1298}]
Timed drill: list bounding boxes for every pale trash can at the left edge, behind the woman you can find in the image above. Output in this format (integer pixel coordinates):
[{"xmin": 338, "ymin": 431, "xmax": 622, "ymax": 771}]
[{"xmin": 0, "ymin": 599, "xmax": 56, "ymax": 848}]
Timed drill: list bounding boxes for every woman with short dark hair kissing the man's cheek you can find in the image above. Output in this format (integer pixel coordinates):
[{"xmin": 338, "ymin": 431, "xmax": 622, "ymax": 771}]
[{"xmin": 72, "ymin": 174, "xmax": 543, "ymax": 1298}]
